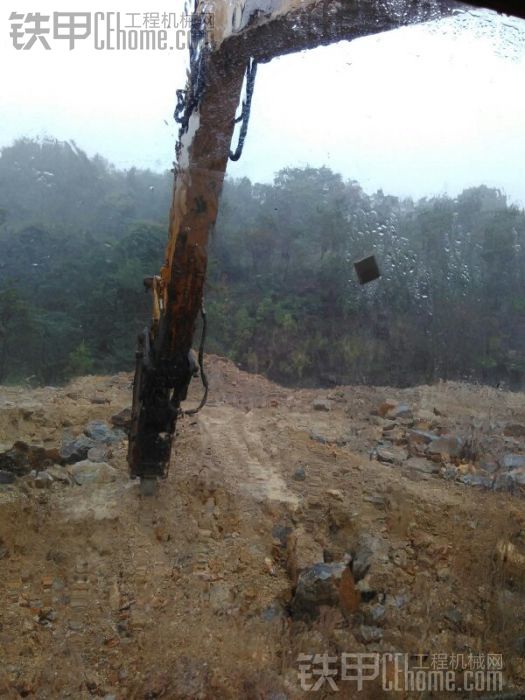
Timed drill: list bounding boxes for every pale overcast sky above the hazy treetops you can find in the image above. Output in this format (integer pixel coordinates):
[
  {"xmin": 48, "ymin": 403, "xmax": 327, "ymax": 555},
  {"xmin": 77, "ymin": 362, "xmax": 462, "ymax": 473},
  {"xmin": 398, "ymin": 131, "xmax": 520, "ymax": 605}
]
[{"xmin": 0, "ymin": 0, "xmax": 525, "ymax": 204}]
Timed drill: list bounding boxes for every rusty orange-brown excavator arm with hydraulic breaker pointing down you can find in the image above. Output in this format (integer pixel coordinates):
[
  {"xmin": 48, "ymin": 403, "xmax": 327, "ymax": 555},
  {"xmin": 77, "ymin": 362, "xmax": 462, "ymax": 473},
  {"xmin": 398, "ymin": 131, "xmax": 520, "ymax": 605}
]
[{"xmin": 128, "ymin": 0, "xmax": 525, "ymax": 492}]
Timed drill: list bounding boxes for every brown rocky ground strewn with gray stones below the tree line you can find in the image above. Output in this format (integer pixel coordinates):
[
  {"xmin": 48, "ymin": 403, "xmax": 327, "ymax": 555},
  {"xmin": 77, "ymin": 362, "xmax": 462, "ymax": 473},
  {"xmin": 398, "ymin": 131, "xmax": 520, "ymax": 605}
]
[{"xmin": 0, "ymin": 357, "xmax": 525, "ymax": 700}]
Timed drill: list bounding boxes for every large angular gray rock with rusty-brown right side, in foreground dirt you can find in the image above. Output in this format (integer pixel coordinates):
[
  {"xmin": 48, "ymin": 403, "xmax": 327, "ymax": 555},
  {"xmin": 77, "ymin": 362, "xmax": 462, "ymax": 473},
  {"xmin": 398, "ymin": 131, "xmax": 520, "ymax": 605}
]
[{"xmin": 291, "ymin": 562, "xmax": 347, "ymax": 618}]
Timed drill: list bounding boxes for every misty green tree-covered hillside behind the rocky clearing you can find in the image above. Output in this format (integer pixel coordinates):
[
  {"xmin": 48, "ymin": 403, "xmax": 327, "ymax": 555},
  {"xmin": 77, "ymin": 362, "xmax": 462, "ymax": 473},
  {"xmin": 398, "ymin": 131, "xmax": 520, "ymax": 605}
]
[{"xmin": 0, "ymin": 139, "xmax": 525, "ymax": 388}]
